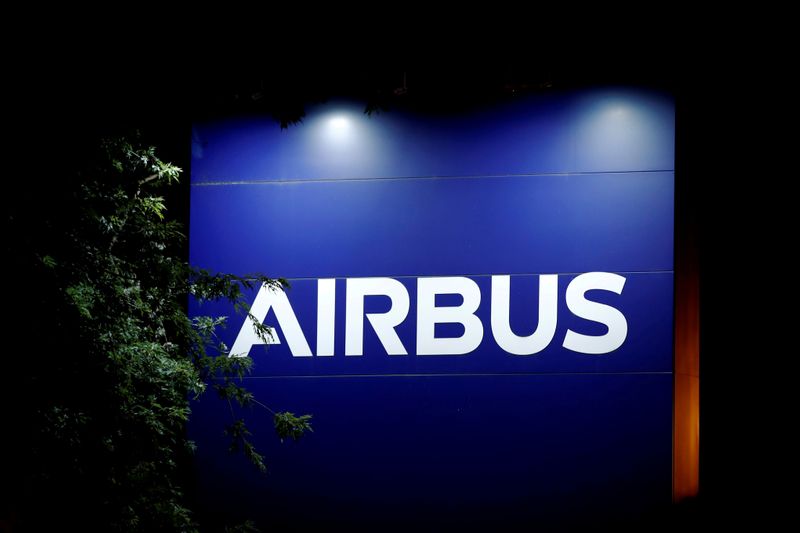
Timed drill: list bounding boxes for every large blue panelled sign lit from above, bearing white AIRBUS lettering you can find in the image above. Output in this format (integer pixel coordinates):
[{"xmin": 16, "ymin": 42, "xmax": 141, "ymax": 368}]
[{"xmin": 190, "ymin": 90, "xmax": 674, "ymax": 527}]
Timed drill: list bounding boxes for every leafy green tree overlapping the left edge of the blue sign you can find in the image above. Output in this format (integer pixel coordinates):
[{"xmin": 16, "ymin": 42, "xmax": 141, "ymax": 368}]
[{"xmin": 7, "ymin": 140, "xmax": 311, "ymax": 531}]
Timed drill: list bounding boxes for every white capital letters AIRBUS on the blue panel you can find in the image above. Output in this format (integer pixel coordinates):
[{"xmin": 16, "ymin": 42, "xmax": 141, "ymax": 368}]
[{"xmin": 230, "ymin": 272, "xmax": 628, "ymax": 357}]
